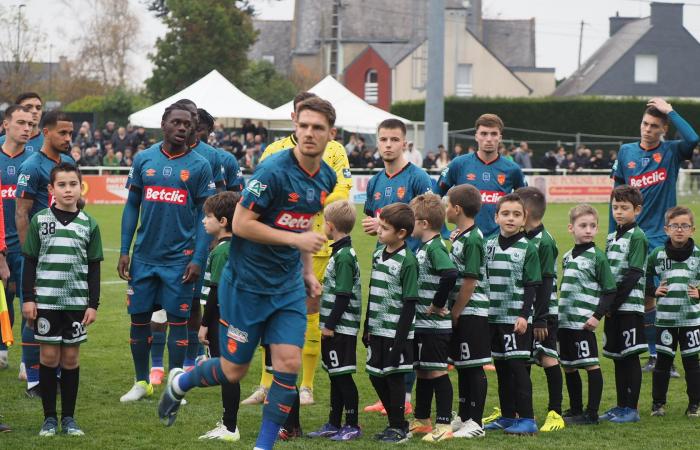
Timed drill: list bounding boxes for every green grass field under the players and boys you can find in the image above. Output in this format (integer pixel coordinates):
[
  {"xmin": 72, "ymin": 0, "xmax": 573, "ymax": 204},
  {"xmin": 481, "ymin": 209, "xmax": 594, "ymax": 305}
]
[{"xmin": 0, "ymin": 202, "xmax": 700, "ymax": 449}]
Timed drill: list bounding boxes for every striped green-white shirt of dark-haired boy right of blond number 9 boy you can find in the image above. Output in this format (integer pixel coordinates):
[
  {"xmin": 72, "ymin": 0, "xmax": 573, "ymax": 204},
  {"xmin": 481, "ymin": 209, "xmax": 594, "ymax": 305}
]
[{"xmin": 367, "ymin": 245, "xmax": 418, "ymax": 339}]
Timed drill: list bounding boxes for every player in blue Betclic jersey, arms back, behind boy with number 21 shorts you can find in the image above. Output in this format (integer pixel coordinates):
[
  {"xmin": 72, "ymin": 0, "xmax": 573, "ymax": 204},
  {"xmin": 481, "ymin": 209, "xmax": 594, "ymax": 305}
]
[{"xmin": 438, "ymin": 114, "xmax": 525, "ymax": 237}]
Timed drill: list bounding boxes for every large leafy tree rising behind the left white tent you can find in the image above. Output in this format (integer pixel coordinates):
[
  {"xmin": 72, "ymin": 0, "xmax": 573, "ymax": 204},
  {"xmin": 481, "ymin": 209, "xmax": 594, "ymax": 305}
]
[{"xmin": 146, "ymin": 0, "xmax": 257, "ymax": 99}]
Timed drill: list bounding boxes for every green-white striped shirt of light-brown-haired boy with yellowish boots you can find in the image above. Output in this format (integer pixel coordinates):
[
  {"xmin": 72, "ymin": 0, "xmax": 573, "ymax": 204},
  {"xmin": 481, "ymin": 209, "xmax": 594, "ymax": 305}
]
[{"xmin": 416, "ymin": 234, "xmax": 455, "ymax": 333}]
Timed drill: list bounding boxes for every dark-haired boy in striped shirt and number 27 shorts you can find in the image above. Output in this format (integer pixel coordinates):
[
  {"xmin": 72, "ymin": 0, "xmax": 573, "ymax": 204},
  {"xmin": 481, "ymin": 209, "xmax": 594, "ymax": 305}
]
[{"xmin": 600, "ymin": 184, "xmax": 649, "ymax": 423}]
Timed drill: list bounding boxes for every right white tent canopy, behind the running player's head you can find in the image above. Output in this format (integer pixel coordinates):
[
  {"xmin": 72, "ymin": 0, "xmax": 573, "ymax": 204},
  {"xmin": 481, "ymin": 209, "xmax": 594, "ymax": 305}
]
[{"xmin": 270, "ymin": 75, "xmax": 411, "ymax": 133}]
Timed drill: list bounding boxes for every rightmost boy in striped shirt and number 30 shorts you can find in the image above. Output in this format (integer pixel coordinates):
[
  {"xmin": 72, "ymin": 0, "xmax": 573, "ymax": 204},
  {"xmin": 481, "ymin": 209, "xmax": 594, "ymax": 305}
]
[{"xmin": 646, "ymin": 206, "xmax": 700, "ymax": 417}]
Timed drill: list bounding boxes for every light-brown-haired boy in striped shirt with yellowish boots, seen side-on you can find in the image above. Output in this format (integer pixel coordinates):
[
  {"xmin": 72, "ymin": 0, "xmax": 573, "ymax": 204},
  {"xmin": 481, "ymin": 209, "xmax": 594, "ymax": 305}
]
[{"xmin": 409, "ymin": 194, "xmax": 457, "ymax": 442}]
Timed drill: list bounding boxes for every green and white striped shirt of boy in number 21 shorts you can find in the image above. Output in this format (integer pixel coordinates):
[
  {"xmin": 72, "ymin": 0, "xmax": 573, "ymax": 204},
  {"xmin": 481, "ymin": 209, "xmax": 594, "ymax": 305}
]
[{"xmin": 486, "ymin": 233, "xmax": 542, "ymax": 324}]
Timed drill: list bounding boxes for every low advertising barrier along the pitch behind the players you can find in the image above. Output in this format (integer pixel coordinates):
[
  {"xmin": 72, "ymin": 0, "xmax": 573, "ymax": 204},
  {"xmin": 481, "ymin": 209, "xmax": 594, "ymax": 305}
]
[{"xmin": 69, "ymin": 167, "xmax": 700, "ymax": 205}]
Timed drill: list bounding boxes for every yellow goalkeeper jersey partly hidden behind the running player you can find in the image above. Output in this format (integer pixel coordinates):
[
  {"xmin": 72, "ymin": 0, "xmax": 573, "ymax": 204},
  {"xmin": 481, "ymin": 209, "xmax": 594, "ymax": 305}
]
[{"xmin": 260, "ymin": 134, "xmax": 352, "ymax": 258}]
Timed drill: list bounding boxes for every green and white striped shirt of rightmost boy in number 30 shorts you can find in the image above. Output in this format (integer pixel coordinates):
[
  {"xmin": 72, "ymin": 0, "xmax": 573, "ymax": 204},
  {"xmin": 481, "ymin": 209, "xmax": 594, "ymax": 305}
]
[{"xmin": 647, "ymin": 245, "xmax": 700, "ymax": 328}]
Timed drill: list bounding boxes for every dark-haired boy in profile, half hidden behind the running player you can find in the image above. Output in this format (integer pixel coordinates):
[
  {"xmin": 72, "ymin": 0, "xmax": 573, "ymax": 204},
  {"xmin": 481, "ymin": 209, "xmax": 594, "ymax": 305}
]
[{"xmin": 198, "ymin": 191, "xmax": 241, "ymax": 442}]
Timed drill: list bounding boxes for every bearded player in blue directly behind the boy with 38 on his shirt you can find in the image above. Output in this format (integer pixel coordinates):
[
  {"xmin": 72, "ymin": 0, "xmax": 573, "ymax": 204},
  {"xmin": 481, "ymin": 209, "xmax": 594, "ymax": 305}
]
[{"xmin": 15, "ymin": 111, "xmax": 75, "ymax": 398}]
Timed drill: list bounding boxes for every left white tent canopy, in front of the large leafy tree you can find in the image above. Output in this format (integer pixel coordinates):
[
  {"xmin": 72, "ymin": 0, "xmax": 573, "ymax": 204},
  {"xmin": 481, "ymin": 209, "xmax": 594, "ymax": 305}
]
[{"xmin": 129, "ymin": 70, "xmax": 272, "ymax": 128}]
